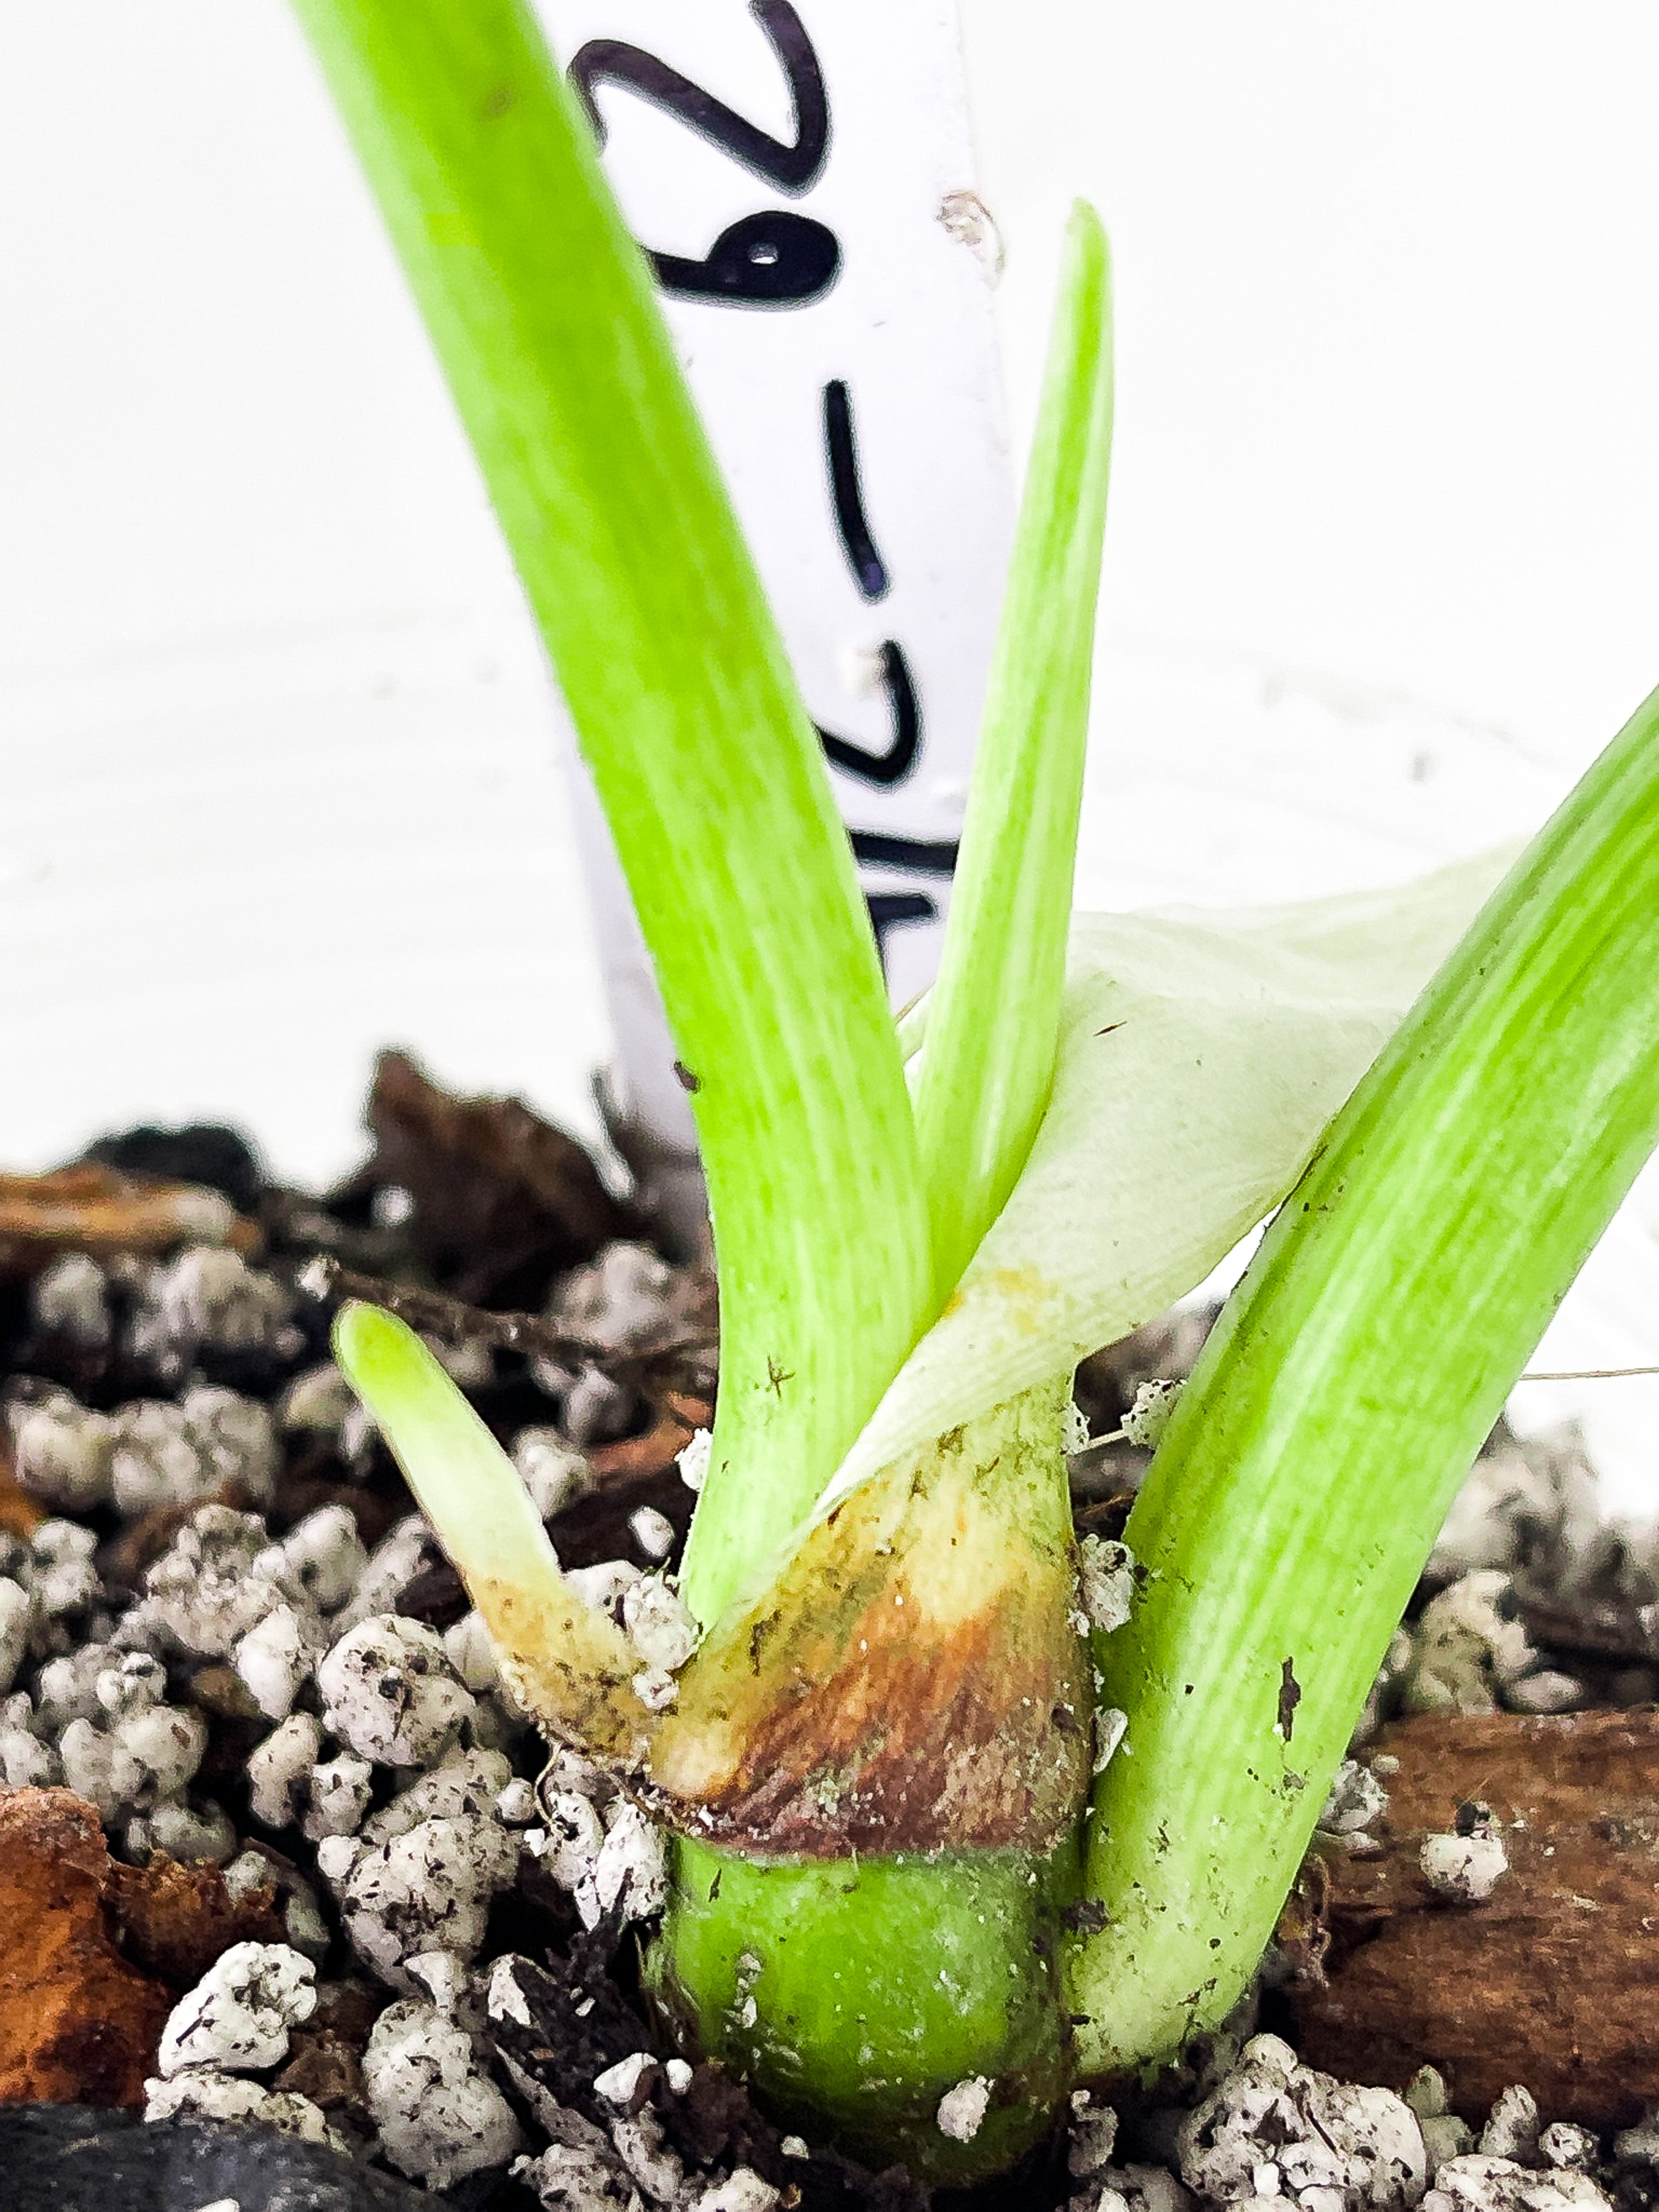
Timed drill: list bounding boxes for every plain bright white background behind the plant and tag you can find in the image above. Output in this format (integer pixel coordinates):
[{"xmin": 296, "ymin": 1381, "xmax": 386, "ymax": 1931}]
[{"xmin": 0, "ymin": 0, "xmax": 1659, "ymax": 1480}]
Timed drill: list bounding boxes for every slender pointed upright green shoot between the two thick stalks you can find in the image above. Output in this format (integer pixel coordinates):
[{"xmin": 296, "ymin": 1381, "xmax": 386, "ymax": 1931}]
[{"xmin": 916, "ymin": 201, "xmax": 1112, "ymax": 1298}]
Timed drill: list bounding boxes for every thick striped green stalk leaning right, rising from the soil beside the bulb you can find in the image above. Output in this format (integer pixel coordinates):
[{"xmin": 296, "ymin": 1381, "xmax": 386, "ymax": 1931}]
[{"xmin": 1073, "ymin": 692, "xmax": 1659, "ymax": 2070}]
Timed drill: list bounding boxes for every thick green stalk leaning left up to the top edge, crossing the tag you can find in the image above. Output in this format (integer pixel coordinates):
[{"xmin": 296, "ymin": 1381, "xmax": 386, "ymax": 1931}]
[{"xmin": 296, "ymin": 0, "xmax": 931, "ymax": 1619}]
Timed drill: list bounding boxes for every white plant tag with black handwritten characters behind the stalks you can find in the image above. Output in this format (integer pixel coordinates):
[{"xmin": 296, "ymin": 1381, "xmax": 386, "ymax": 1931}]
[{"xmin": 537, "ymin": 0, "xmax": 1013, "ymax": 1148}]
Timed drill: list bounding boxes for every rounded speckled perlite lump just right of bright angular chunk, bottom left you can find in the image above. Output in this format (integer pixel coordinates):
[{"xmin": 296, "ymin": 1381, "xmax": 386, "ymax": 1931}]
[{"xmin": 363, "ymin": 2000, "xmax": 522, "ymax": 2190}]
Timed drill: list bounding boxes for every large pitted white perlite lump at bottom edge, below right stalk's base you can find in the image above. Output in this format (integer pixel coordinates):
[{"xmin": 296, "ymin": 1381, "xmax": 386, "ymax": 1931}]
[{"xmin": 1177, "ymin": 2035, "xmax": 1427, "ymax": 2212}]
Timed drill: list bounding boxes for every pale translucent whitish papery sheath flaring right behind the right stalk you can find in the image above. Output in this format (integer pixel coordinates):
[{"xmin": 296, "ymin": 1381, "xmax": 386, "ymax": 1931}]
[{"xmin": 819, "ymin": 852, "xmax": 1511, "ymax": 1513}]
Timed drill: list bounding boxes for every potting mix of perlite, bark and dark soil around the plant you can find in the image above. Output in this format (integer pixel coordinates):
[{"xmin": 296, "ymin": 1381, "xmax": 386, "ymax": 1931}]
[{"xmin": 0, "ymin": 1055, "xmax": 1659, "ymax": 2212}]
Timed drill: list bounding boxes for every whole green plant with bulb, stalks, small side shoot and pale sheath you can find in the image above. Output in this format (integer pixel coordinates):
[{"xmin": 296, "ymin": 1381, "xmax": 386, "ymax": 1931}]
[{"xmin": 296, "ymin": 0, "xmax": 1659, "ymax": 2179}]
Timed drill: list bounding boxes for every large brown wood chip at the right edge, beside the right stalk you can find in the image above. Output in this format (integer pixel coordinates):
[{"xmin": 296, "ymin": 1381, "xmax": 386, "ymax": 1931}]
[{"xmin": 1294, "ymin": 1710, "xmax": 1659, "ymax": 2128}]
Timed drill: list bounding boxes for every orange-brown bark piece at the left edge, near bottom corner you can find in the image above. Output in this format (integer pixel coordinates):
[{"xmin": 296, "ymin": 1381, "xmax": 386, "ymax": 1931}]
[{"xmin": 0, "ymin": 1790, "xmax": 175, "ymax": 2106}]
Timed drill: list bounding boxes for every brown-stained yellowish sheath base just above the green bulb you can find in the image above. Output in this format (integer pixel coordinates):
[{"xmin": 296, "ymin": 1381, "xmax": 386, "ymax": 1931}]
[{"xmin": 648, "ymin": 1383, "xmax": 1092, "ymax": 1858}]
